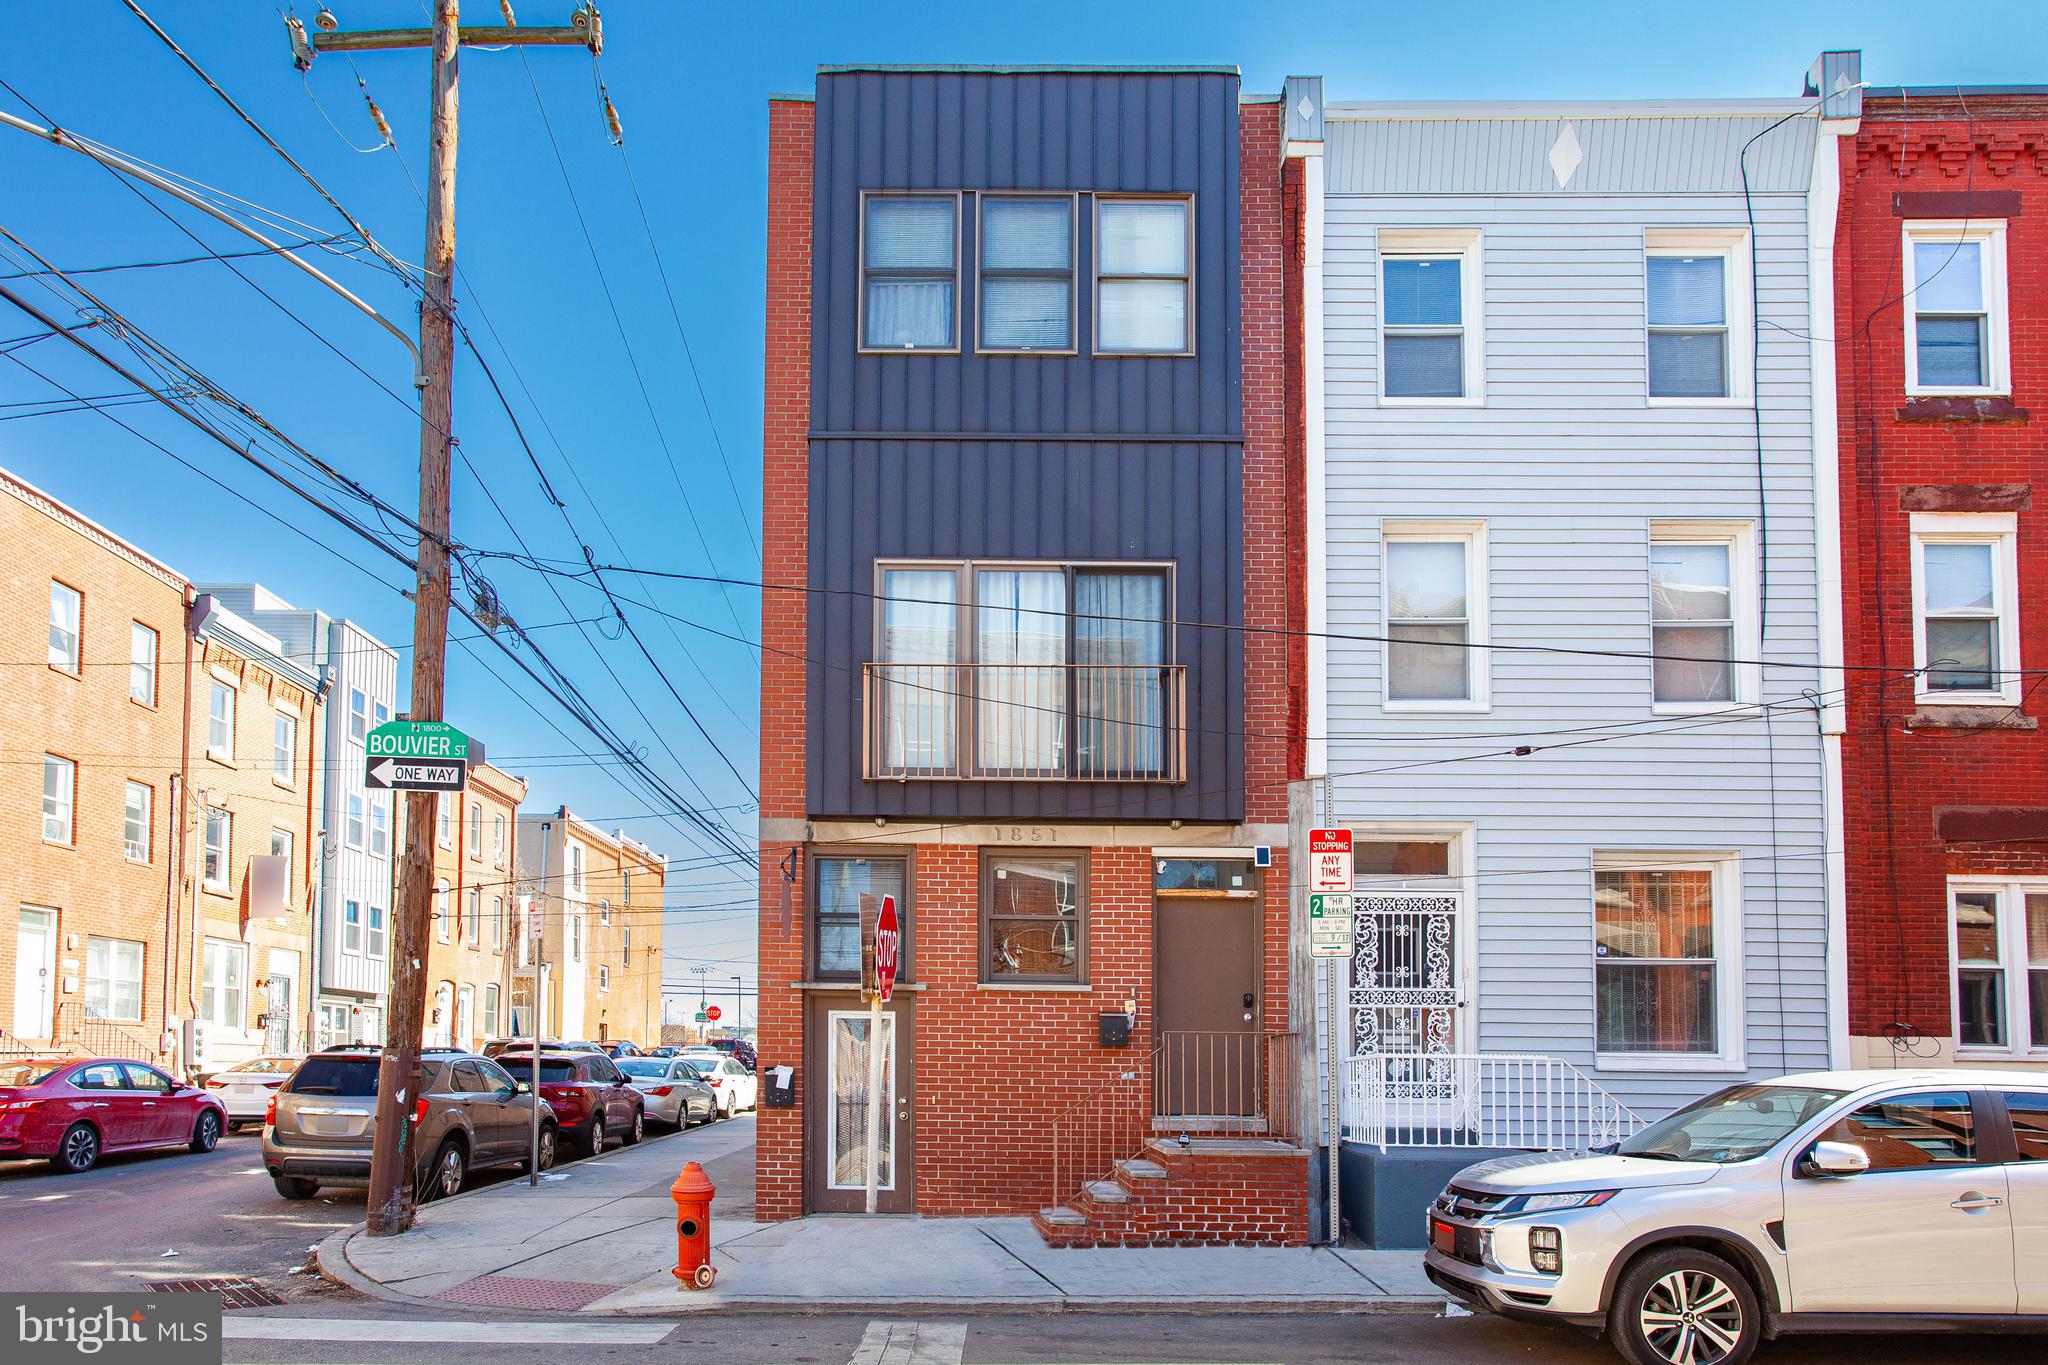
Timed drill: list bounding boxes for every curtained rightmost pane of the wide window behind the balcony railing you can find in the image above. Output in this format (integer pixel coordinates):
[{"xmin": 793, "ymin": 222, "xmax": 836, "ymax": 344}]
[{"xmin": 1073, "ymin": 573, "xmax": 1167, "ymax": 776}]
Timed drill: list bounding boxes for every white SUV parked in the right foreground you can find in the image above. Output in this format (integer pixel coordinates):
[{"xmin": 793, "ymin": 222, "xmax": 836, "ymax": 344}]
[{"xmin": 1423, "ymin": 1070, "xmax": 2048, "ymax": 1365}]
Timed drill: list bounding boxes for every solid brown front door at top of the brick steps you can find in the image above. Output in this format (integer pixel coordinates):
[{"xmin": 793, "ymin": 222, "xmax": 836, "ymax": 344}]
[{"xmin": 1153, "ymin": 888, "xmax": 1264, "ymax": 1132}]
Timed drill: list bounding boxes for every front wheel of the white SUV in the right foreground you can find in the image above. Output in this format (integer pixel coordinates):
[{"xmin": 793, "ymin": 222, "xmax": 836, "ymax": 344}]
[{"xmin": 1608, "ymin": 1246, "xmax": 1763, "ymax": 1365}]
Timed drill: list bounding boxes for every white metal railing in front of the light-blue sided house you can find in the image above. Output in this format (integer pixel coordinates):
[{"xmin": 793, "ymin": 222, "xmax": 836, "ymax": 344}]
[{"xmin": 1343, "ymin": 1052, "xmax": 1645, "ymax": 1152}]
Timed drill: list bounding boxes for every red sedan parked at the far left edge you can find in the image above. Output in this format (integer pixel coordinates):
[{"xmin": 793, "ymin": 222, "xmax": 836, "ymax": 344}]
[{"xmin": 0, "ymin": 1058, "xmax": 227, "ymax": 1173}]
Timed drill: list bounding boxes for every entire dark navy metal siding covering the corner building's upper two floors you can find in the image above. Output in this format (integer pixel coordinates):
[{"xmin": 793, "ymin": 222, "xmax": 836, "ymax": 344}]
[{"xmin": 807, "ymin": 72, "xmax": 1243, "ymax": 821}]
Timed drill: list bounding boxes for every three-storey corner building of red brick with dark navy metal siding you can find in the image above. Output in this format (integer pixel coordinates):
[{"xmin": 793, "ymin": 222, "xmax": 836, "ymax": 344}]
[{"xmin": 756, "ymin": 68, "xmax": 1307, "ymax": 1242}]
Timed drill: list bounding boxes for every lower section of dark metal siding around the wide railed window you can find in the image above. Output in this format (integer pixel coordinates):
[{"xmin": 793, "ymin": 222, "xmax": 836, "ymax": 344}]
[{"xmin": 805, "ymin": 440, "xmax": 1245, "ymax": 821}]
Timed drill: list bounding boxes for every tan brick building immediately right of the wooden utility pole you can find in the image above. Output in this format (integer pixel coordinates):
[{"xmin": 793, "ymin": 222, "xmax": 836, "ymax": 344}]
[{"xmin": 426, "ymin": 763, "xmax": 526, "ymax": 1048}]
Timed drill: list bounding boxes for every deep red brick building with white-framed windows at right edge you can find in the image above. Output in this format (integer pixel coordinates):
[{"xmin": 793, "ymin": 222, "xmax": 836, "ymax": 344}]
[{"xmin": 1835, "ymin": 86, "xmax": 2048, "ymax": 1066}]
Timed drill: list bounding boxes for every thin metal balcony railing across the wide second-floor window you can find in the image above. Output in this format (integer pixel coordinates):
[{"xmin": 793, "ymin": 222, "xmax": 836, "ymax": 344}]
[{"xmin": 862, "ymin": 663, "xmax": 1188, "ymax": 782}]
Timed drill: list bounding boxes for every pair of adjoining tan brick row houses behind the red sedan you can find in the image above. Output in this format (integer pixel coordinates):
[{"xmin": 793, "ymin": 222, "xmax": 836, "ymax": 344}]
[{"xmin": 0, "ymin": 475, "xmax": 319, "ymax": 1068}]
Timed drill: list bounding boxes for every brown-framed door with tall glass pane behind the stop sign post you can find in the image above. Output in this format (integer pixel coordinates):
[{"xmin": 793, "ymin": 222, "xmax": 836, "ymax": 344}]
[{"xmin": 805, "ymin": 990, "xmax": 918, "ymax": 1214}]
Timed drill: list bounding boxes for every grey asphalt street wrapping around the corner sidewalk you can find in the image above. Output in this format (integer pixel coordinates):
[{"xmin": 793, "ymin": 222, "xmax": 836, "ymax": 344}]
[{"xmin": 0, "ymin": 1117, "xmax": 2048, "ymax": 1365}]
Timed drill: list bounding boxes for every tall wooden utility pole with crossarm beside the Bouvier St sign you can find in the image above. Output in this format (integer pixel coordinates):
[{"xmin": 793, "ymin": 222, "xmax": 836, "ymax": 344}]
[{"xmin": 301, "ymin": 0, "xmax": 604, "ymax": 1236}]
